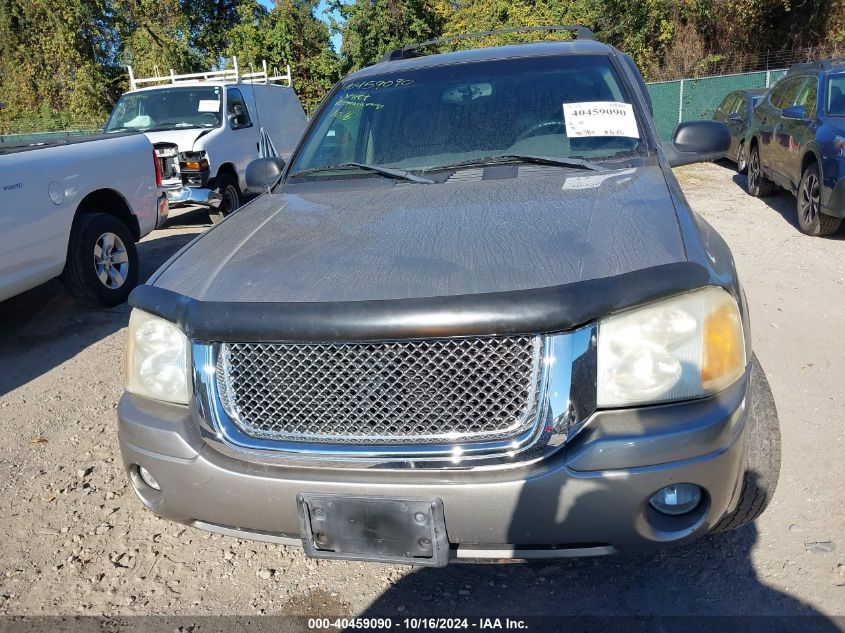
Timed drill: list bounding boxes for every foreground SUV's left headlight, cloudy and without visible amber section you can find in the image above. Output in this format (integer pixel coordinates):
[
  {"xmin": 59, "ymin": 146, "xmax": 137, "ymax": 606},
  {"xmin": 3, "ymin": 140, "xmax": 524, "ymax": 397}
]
[{"xmin": 126, "ymin": 310, "xmax": 191, "ymax": 404}]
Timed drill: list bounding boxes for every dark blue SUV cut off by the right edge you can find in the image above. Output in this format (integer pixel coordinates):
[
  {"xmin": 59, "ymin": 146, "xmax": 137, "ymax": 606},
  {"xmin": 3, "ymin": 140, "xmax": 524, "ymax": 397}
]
[{"xmin": 748, "ymin": 58, "xmax": 845, "ymax": 236}]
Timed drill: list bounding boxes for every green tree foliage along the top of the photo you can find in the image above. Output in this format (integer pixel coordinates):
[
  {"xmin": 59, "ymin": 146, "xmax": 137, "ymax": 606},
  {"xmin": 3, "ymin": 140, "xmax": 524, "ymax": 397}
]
[{"xmin": 0, "ymin": 0, "xmax": 845, "ymax": 133}]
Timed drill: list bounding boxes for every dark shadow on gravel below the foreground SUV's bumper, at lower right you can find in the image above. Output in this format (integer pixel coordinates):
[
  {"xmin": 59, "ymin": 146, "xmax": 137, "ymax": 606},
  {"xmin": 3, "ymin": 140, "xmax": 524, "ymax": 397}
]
[{"xmin": 360, "ymin": 504, "xmax": 845, "ymax": 633}]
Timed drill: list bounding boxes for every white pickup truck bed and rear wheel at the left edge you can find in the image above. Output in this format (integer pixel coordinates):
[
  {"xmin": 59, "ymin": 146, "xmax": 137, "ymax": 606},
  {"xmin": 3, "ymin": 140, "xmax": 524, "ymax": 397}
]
[{"xmin": 0, "ymin": 134, "xmax": 168, "ymax": 306}]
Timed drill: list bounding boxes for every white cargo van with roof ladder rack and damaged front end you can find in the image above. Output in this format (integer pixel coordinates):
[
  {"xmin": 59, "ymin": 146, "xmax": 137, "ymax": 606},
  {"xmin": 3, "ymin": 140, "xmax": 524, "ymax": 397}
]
[{"xmin": 105, "ymin": 59, "xmax": 306, "ymax": 222}]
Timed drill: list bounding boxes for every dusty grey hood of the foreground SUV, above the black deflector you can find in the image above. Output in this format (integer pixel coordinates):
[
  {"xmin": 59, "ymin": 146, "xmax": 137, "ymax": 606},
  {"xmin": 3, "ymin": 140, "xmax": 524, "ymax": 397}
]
[{"xmin": 153, "ymin": 166, "xmax": 686, "ymax": 302}]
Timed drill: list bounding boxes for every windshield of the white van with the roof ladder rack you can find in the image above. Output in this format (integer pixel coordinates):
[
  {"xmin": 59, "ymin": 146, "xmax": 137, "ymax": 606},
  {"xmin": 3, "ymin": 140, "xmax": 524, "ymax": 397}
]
[{"xmin": 106, "ymin": 87, "xmax": 222, "ymax": 132}]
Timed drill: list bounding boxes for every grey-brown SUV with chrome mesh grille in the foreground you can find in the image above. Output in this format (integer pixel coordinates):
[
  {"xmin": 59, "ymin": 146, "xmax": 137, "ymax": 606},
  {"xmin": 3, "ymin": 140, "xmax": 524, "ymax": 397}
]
[{"xmin": 118, "ymin": 27, "xmax": 780, "ymax": 565}]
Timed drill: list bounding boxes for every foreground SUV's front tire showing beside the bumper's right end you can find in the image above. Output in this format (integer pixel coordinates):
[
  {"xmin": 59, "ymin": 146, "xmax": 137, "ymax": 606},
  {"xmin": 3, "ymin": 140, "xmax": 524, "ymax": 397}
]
[{"xmin": 713, "ymin": 356, "xmax": 780, "ymax": 532}]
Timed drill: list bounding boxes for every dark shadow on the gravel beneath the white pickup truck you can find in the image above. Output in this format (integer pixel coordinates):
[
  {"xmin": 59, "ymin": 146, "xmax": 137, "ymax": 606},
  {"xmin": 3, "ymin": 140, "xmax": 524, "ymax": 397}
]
[{"xmin": 0, "ymin": 227, "xmax": 207, "ymax": 396}]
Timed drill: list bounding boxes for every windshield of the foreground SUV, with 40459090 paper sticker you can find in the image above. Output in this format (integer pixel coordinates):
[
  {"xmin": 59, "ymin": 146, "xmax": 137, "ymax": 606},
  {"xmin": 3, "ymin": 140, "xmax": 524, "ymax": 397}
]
[{"xmin": 291, "ymin": 55, "xmax": 643, "ymax": 177}]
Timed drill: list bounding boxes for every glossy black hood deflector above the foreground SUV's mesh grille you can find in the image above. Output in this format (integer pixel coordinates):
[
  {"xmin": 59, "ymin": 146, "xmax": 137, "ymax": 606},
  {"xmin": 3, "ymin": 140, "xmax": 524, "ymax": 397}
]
[{"xmin": 129, "ymin": 262, "xmax": 711, "ymax": 342}]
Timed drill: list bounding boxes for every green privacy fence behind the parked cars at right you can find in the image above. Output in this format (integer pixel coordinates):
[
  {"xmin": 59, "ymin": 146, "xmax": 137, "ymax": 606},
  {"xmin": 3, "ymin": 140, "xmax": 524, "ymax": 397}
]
[{"xmin": 647, "ymin": 69, "xmax": 786, "ymax": 140}]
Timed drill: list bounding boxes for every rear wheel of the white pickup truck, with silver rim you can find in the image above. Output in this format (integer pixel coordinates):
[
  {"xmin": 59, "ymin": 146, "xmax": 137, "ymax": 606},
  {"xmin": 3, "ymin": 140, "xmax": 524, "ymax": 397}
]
[{"xmin": 61, "ymin": 213, "xmax": 138, "ymax": 306}]
